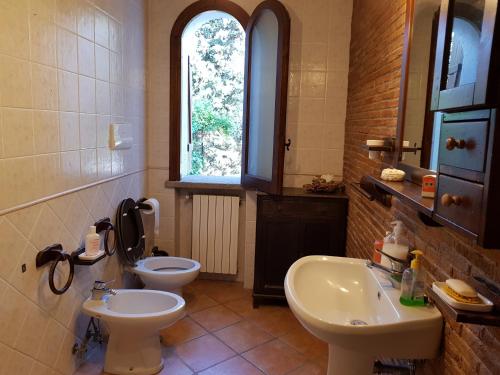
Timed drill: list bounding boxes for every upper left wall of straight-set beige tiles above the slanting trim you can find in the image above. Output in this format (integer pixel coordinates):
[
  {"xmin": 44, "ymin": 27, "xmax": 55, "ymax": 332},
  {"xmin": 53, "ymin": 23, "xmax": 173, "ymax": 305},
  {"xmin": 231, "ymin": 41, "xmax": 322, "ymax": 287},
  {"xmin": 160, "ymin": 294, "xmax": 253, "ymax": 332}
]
[{"xmin": 0, "ymin": 0, "xmax": 146, "ymax": 212}]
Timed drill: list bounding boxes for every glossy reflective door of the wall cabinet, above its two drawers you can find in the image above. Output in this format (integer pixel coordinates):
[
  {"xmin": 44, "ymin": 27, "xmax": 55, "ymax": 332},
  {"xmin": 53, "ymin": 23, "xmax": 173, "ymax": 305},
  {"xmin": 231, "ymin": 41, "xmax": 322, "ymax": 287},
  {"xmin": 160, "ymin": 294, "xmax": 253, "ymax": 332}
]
[{"xmin": 432, "ymin": 0, "xmax": 497, "ymax": 110}]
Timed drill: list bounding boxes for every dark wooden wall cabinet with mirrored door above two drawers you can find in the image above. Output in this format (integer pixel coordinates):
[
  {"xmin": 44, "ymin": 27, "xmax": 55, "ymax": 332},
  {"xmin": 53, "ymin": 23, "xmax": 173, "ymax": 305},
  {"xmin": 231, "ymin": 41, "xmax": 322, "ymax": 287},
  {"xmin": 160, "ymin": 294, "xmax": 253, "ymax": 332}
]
[{"xmin": 431, "ymin": 0, "xmax": 500, "ymax": 248}]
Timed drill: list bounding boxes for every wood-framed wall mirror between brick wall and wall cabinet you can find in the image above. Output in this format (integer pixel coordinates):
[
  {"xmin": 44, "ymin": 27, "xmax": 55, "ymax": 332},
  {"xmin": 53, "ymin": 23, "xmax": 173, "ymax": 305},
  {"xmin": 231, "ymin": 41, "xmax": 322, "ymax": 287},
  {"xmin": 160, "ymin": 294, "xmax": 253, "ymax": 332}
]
[{"xmin": 398, "ymin": 0, "xmax": 441, "ymax": 170}]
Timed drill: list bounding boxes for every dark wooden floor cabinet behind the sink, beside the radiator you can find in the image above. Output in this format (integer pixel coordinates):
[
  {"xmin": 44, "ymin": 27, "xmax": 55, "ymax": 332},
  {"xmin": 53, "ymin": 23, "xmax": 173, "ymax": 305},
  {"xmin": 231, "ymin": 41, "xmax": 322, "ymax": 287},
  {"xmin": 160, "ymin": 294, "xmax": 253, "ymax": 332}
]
[{"xmin": 253, "ymin": 189, "xmax": 348, "ymax": 306}]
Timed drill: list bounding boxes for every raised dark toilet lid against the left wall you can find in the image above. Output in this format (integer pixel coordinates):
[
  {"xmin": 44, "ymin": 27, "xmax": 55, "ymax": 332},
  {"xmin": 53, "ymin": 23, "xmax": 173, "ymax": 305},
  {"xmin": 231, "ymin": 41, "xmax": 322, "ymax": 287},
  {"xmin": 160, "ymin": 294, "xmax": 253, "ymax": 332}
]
[{"xmin": 116, "ymin": 198, "xmax": 145, "ymax": 266}]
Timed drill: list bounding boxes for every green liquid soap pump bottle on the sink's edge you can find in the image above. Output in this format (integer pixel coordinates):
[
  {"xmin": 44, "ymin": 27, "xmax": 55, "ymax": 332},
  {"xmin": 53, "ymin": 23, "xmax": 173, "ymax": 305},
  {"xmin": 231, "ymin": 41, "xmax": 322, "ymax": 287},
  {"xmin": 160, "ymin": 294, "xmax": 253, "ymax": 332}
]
[{"xmin": 399, "ymin": 250, "xmax": 426, "ymax": 306}]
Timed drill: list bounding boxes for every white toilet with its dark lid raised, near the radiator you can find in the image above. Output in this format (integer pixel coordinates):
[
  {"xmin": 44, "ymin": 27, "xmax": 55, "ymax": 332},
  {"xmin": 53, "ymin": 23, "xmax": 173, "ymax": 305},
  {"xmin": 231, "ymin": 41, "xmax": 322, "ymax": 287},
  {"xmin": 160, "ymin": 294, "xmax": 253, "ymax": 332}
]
[{"xmin": 116, "ymin": 198, "xmax": 200, "ymax": 295}]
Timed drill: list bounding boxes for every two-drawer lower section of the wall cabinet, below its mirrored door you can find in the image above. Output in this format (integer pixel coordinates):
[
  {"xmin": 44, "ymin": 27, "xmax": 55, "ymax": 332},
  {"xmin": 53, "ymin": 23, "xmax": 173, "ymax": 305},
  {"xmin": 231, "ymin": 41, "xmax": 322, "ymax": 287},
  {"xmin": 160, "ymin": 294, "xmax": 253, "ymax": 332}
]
[{"xmin": 433, "ymin": 108, "xmax": 500, "ymax": 248}]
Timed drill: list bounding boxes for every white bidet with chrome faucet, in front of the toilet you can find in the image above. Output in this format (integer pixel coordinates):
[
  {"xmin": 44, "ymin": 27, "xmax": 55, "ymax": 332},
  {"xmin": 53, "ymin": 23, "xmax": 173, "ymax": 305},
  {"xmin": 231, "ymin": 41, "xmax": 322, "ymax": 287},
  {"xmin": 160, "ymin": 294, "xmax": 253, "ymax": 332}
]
[{"xmin": 83, "ymin": 289, "xmax": 185, "ymax": 375}]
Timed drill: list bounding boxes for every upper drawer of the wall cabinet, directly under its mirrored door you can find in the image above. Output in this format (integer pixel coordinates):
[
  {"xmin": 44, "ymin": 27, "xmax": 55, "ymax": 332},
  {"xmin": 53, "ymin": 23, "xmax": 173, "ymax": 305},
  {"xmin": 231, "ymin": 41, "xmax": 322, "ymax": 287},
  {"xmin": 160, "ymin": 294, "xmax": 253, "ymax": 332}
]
[{"xmin": 439, "ymin": 121, "xmax": 488, "ymax": 173}]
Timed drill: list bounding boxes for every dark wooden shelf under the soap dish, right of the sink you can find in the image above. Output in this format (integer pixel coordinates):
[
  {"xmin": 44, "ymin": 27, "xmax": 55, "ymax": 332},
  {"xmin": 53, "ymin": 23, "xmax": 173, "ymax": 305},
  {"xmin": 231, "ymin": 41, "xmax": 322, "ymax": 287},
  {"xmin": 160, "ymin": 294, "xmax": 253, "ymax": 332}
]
[{"xmin": 427, "ymin": 288, "xmax": 500, "ymax": 327}]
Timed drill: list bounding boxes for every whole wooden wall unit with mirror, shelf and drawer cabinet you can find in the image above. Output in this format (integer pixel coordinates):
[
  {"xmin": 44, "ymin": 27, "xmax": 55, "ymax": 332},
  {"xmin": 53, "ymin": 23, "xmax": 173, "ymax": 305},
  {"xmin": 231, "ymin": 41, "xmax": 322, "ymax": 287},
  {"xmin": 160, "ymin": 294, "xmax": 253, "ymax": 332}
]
[{"xmin": 388, "ymin": 0, "xmax": 500, "ymax": 249}]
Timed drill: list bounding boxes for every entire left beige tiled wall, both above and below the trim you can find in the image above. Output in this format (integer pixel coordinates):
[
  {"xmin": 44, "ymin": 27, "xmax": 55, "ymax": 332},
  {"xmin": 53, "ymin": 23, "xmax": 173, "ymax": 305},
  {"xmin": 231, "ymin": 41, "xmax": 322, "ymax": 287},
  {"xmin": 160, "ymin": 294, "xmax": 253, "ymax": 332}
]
[{"xmin": 0, "ymin": 0, "xmax": 146, "ymax": 375}]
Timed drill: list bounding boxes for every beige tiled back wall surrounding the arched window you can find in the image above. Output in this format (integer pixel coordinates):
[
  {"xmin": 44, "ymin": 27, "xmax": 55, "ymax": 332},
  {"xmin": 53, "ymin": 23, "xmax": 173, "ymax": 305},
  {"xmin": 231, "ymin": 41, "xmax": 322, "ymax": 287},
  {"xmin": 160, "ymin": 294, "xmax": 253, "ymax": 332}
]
[{"xmin": 148, "ymin": 0, "xmax": 352, "ymax": 286}]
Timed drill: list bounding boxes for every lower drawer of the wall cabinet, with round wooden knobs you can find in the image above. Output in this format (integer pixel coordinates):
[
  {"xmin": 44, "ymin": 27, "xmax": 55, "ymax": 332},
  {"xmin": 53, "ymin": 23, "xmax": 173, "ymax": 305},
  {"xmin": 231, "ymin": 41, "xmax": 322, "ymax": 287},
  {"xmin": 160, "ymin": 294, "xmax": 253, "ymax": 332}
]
[{"xmin": 437, "ymin": 175, "xmax": 483, "ymax": 233}]
